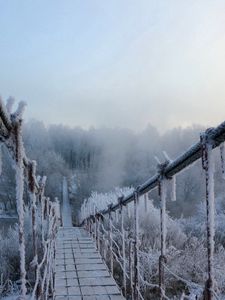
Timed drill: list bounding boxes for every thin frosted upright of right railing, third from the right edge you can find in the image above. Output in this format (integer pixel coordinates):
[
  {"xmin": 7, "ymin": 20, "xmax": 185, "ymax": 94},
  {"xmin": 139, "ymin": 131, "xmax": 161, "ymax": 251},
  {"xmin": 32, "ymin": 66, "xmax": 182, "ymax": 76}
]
[{"xmin": 134, "ymin": 188, "xmax": 139, "ymax": 300}]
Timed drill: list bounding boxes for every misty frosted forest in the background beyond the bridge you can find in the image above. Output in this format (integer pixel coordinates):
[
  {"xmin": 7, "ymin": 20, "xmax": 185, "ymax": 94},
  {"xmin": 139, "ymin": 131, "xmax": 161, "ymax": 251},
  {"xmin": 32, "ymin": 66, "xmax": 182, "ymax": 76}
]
[{"xmin": 0, "ymin": 120, "xmax": 223, "ymax": 216}]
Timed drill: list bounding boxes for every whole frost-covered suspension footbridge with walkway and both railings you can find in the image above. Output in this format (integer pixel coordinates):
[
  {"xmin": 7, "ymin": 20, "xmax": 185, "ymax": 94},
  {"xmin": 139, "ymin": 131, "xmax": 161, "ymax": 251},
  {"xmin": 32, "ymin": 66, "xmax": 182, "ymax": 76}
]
[{"xmin": 0, "ymin": 98, "xmax": 225, "ymax": 300}]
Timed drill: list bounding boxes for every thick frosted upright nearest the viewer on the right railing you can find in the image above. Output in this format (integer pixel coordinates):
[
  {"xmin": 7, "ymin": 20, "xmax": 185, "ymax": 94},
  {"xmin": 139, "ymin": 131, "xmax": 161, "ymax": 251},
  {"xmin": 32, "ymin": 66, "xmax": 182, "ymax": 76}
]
[{"xmin": 201, "ymin": 128, "xmax": 215, "ymax": 300}]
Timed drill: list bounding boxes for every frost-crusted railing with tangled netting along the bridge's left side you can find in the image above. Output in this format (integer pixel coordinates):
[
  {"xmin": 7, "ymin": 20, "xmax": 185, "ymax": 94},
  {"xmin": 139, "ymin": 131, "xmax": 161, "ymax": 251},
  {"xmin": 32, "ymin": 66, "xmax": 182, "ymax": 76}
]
[{"xmin": 0, "ymin": 98, "xmax": 59, "ymax": 299}]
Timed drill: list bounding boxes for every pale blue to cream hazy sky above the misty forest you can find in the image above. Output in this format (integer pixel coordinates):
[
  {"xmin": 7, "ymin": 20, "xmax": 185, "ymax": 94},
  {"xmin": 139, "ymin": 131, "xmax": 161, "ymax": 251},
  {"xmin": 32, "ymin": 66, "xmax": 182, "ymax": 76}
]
[{"xmin": 0, "ymin": 0, "xmax": 225, "ymax": 130}]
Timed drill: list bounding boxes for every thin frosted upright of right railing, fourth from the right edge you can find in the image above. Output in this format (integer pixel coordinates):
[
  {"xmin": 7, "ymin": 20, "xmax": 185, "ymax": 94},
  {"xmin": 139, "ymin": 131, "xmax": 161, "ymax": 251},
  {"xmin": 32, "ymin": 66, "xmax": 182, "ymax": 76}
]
[{"xmin": 118, "ymin": 196, "xmax": 127, "ymax": 298}]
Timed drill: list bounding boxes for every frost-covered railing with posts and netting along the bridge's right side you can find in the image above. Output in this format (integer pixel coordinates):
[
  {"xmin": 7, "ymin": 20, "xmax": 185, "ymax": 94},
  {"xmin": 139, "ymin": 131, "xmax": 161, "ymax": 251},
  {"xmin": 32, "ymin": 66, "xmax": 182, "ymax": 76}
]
[{"xmin": 80, "ymin": 122, "xmax": 225, "ymax": 300}]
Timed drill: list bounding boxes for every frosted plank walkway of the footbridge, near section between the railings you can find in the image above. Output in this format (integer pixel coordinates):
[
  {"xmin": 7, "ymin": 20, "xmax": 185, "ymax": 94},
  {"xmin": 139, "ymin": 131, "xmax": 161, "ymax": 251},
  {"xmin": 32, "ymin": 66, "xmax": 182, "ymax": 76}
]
[{"xmin": 54, "ymin": 227, "xmax": 124, "ymax": 300}]
